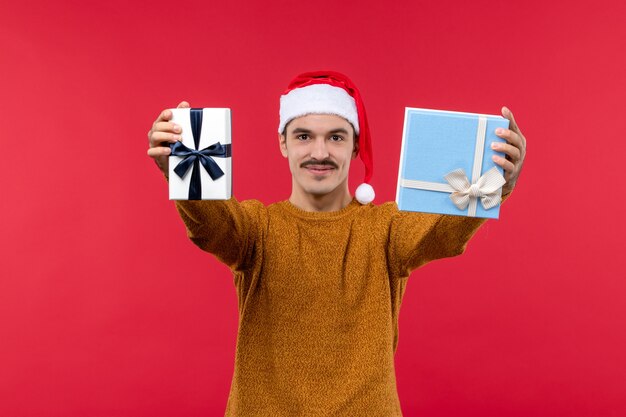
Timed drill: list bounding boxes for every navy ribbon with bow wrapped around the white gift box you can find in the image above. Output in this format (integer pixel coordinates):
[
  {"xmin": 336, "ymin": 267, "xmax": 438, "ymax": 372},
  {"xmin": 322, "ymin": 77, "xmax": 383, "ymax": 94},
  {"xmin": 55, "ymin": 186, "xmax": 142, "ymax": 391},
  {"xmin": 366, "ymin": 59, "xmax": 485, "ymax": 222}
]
[{"xmin": 170, "ymin": 109, "xmax": 231, "ymax": 200}]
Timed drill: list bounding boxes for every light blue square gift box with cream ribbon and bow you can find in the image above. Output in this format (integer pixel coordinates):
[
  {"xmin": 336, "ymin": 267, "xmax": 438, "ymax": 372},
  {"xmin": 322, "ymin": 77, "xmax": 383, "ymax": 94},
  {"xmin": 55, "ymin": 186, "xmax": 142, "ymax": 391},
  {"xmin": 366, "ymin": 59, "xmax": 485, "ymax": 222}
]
[{"xmin": 396, "ymin": 107, "xmax": 509, "ymax": 219}]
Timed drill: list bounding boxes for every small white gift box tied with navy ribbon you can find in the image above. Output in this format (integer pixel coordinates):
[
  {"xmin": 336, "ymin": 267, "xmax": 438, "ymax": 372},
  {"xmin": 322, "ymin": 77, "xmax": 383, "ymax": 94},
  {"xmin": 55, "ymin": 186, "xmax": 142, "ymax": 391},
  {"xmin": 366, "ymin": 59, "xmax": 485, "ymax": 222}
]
[{"xmin": 169, "ymin": 108, "xmax": 232, "ymax": 200}]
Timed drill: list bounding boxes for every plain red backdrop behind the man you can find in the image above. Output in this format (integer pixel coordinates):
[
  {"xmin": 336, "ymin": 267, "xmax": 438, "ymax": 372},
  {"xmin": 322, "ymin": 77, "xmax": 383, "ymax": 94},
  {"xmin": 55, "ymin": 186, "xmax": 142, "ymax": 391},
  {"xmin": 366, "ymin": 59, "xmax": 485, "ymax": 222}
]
[{"xmin": 0, "ymin": 0, "xmax": 626, "ymax": 417}]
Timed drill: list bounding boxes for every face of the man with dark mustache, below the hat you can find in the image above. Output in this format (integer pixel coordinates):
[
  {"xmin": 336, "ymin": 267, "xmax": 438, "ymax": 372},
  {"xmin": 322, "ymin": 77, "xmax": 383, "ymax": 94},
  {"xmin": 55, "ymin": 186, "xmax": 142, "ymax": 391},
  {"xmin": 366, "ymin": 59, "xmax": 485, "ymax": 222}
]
[{"xmin": 279, "ymin": 114, "xmax": 358, "ymax": 197}]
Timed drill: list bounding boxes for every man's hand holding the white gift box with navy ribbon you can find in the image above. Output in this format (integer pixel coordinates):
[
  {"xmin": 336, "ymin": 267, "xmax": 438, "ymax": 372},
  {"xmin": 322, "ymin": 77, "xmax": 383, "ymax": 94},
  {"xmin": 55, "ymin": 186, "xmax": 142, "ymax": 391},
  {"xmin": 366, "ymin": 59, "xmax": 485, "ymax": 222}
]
[{"xmin": 148, "ymin": 101, "xmax": 189, "ymax": 177}]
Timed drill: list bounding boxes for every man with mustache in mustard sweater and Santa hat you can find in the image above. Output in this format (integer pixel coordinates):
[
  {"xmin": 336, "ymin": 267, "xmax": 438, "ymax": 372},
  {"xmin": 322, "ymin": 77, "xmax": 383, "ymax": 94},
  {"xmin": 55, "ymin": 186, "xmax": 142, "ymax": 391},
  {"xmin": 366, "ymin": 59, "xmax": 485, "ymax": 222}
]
[{"xmin": 148, "ymin": 71, "xmax": 526, "ymax": 417}]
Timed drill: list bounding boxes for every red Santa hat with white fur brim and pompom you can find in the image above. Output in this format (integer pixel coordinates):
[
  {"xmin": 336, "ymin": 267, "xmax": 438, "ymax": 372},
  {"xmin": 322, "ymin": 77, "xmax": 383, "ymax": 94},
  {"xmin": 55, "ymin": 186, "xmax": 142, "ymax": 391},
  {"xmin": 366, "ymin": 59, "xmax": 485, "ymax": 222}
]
[{"xmin": 278, "ymin": 71, "xmax": 375, "ymax": 204}]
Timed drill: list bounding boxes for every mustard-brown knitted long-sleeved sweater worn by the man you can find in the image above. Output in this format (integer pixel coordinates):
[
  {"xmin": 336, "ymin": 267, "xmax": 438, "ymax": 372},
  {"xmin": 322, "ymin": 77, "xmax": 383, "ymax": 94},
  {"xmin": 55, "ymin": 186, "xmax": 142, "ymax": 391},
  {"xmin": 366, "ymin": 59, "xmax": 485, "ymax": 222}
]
[{"xmin": 177, "ymin": 199, "xmax": 483, "ymax": 417}]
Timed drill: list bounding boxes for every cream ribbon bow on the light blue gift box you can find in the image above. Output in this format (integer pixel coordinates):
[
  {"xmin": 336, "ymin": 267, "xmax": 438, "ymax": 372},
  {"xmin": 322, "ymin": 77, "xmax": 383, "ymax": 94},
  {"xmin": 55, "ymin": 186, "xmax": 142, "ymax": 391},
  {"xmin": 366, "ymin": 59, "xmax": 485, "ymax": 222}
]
[{"xmin": 444, "ymin": 167, "xmax": 506, "ymax": 210}]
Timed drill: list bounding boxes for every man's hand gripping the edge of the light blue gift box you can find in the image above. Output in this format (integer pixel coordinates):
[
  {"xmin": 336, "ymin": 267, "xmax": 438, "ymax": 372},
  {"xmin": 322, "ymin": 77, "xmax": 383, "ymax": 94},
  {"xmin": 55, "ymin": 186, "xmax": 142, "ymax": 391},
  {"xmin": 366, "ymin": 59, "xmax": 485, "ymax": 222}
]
[{"xmin": 491, "ymin": 107, "xmax": 526, "ymax": 195}]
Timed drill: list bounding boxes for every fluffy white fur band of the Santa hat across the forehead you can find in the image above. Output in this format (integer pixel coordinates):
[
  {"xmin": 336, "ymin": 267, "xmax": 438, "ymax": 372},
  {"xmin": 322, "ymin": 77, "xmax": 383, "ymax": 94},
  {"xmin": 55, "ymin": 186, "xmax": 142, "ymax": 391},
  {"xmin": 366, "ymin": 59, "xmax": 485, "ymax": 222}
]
[{"xmin": 278, "ymin": 84, "xmax": 359, "ymax": 135}]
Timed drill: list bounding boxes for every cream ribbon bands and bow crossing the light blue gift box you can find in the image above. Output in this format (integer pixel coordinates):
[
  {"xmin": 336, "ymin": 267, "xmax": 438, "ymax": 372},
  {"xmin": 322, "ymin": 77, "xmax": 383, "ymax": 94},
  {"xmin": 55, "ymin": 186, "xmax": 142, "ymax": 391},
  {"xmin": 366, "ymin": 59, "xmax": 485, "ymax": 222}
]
[{"xmin": 400, "ymin": 116, "xmax": 506, "ymax": 217}]
